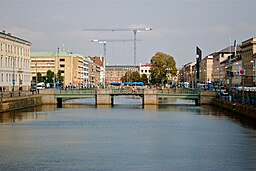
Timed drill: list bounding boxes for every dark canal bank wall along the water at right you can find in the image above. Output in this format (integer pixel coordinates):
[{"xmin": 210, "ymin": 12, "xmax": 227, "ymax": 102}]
[{"xmin": 212, "ymin": 98, "xmax": 256, "ymax": 120}]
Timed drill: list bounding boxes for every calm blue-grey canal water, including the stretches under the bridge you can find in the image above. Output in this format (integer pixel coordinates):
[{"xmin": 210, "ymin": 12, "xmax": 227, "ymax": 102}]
[{"xmin": 0, "ymin": 97, "xmax": 256, "ymax": 171}]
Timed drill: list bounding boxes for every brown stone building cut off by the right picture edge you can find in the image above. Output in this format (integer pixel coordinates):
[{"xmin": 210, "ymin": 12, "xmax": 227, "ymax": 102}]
[{"xmin": 240, "ymin": 37, "xmax": 256, "ymax": 86}]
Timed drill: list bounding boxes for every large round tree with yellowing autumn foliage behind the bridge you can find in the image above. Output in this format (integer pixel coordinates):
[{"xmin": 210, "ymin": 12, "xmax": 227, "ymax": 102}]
[{"xmin": 150, "ymin": 52, "xmax": 177, "ymax": 84}]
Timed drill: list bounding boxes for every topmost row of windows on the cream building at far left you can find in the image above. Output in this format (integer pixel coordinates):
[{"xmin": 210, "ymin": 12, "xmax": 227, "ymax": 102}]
[{"xmin": 0, "ymin": 43, "xmax": 30, "ymax": 56}]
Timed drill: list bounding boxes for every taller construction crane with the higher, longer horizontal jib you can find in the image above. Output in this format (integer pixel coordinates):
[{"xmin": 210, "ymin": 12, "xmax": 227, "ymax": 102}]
[{"xmin": 83, "ymin": 27, "xmax": 153, "ymax": 65}]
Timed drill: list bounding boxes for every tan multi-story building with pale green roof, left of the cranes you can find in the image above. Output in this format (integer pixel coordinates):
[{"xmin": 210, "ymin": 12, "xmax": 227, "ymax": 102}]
[{"xmin": 31, "ymin": 51, "xmax": 88, "ymax": 86}]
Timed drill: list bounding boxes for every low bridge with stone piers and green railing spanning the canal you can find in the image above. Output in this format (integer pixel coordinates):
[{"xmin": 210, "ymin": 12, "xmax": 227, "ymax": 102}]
[{"xmin": 41, "ymin": 88, "xmax": 215, "ymax": 107}]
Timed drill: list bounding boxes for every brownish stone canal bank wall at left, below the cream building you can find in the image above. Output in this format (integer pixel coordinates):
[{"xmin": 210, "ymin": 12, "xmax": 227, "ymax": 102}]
[{"xmin": 0, "ymin": 95, "xmax": 42, "ymax": 112}]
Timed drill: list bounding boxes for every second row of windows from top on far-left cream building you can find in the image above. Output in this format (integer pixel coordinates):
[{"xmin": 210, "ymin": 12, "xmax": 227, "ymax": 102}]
[{"xmin": 0, "ymin": 55, "xmax": 29, "ymax": 69}]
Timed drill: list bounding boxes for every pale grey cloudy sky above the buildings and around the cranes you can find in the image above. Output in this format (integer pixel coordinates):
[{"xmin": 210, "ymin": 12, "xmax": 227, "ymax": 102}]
[{"xmin": 0, "ymin": 0, "xmax": 256, "ymax": 68}]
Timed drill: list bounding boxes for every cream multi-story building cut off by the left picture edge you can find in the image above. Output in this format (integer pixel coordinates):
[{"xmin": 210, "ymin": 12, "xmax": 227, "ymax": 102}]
[{"xmin": 0, "ymin": 30, "xmax": 32, "ymax": 91}]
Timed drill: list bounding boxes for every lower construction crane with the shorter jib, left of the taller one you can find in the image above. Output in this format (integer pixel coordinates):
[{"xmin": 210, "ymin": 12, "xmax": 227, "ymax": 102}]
[{"xmin": 91, "ymin": 39, "xmax": 141, "ymax": 88}]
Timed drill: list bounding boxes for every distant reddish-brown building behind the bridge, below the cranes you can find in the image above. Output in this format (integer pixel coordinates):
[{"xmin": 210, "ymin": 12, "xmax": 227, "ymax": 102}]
[{"xmin": 106, "ymin": 65, "xmax": 138, "ymax": 85}]
